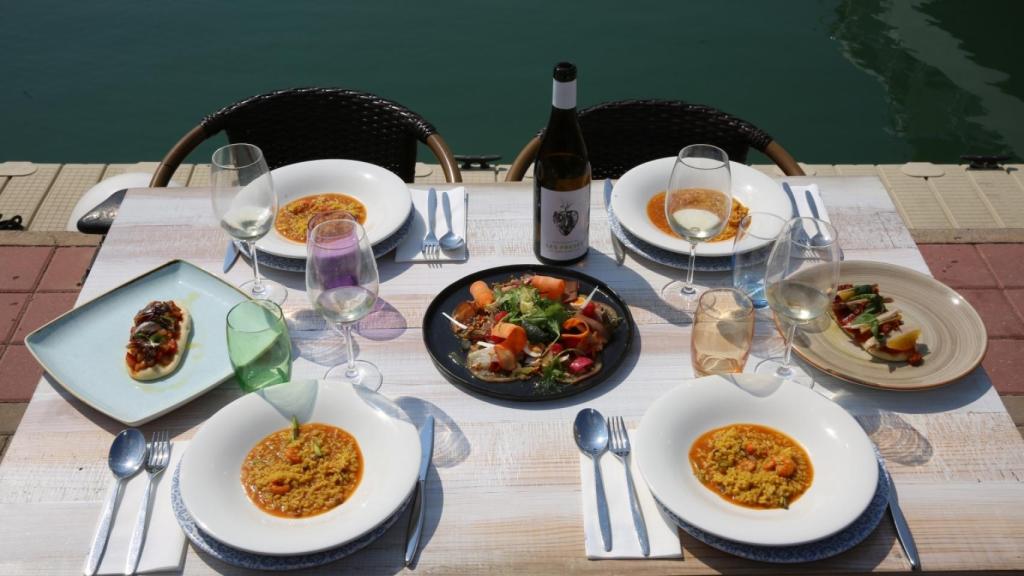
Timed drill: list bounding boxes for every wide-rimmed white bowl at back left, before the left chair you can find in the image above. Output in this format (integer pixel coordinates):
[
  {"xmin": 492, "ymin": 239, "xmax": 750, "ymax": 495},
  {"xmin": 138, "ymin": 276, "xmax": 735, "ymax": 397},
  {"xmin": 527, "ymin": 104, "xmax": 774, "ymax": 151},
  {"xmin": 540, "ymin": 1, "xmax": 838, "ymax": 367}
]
[{"xmin": 256, "ymin": 160, "xmax": 413, "ymax": 258}]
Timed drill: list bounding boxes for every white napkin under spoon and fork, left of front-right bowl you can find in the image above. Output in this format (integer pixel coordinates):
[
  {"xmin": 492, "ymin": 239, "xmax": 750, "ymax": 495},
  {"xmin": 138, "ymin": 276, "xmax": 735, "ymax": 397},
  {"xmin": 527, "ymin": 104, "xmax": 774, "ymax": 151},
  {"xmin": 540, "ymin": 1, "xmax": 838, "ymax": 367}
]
[{"xmin": 580, "ymin": 430, "xmax": 683, "ymax": 560}]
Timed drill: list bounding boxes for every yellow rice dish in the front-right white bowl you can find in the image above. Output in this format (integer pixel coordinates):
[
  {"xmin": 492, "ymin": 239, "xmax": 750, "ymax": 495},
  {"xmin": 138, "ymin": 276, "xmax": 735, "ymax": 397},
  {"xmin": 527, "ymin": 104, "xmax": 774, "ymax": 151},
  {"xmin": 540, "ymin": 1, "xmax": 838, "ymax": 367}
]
[{"xmin": 690, "ymin": 424, "xmax": 814, "ymax": 508}]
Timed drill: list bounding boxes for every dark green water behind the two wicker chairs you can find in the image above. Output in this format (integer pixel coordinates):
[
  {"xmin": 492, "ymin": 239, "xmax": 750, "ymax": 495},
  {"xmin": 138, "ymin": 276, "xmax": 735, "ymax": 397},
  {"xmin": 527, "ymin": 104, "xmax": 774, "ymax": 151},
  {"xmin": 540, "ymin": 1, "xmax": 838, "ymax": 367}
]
[{"xmin": 0, "ymin": 0, "xmax": 1024, "ymax": 163}]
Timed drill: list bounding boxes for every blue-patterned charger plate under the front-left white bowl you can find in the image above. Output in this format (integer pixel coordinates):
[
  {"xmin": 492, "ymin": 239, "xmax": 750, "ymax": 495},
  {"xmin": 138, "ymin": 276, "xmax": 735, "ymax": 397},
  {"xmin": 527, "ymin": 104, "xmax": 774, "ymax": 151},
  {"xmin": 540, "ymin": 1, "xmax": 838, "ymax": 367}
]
[{"xmin": 171, "ymin": 463, "xmax": 412, "ymax": 572}]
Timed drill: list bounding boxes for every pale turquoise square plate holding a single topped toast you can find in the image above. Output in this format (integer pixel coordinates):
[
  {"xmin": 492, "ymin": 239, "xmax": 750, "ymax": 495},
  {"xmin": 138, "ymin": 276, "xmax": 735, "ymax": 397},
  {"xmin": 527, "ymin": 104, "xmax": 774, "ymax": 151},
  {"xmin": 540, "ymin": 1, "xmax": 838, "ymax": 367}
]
[{"xmin": 25, "ymin": 260, "xmax": 246, "ymax": 426}]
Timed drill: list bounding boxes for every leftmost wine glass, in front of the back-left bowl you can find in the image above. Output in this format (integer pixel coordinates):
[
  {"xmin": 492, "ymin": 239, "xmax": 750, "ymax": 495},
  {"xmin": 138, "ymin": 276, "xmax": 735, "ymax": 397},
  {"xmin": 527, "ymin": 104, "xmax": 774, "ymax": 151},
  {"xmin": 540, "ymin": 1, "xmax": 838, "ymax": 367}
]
[{"xmin": 210, "ymin": 143, "xmax": 288, "ymax": 304}]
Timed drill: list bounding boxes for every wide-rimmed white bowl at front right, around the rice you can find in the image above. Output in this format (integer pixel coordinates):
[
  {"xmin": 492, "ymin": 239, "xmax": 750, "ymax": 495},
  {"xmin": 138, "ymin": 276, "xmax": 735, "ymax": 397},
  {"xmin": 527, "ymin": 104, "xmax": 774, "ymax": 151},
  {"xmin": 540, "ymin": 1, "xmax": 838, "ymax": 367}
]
[{"xmin": 636, "ymin": 374, "xmax": 879, "ymax": 546}]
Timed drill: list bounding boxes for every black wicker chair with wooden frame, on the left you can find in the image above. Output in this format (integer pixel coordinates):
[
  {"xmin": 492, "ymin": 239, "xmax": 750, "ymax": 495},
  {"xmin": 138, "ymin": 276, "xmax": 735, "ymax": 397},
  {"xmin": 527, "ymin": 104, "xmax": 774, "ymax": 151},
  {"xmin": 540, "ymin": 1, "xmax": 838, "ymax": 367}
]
[{"xmin": 150, "ymin": 88, "xmax": 462, "ymax": 188}]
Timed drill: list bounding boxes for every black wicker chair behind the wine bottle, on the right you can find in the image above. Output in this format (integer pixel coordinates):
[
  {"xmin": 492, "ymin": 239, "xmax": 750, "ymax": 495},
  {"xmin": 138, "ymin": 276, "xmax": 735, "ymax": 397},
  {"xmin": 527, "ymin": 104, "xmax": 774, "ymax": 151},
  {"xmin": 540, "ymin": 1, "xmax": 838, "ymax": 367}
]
[{"xmin": 505, "ymin": 99, "xmax": 804, "ymax": 181}]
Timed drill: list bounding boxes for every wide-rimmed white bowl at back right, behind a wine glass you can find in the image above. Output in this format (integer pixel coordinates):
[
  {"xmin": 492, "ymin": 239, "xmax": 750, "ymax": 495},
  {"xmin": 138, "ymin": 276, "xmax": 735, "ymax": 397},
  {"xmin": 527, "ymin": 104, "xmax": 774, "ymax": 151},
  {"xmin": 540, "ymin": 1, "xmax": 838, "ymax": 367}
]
[{"xmin": 611, "ymin": 158, "xmax": 793, "ymax": 256}]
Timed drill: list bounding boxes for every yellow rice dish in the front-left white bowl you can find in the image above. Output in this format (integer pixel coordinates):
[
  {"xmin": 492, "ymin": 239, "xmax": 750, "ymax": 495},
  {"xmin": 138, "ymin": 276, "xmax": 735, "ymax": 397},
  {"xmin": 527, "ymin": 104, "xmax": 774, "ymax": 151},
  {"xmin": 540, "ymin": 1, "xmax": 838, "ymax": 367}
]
[{"xmin": 242, "ymin": 420, "xmax": 362, "ymax": 518}]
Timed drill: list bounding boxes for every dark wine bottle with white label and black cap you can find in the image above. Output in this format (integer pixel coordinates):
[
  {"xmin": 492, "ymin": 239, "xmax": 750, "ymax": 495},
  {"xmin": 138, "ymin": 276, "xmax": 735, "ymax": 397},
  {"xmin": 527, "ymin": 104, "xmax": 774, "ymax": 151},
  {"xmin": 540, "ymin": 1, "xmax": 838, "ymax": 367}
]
[{"xmin": 534, "ymin": 63, "xmax": 590, "ymax": 264}]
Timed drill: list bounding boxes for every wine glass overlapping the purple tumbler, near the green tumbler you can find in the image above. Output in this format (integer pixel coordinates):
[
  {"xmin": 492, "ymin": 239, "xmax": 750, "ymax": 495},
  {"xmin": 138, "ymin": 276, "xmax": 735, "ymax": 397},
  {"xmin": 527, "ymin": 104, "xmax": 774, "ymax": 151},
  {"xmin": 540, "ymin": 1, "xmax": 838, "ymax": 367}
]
[{"xmin": 306, "ymin": 219, "xmax": 383, "ymax": 390}]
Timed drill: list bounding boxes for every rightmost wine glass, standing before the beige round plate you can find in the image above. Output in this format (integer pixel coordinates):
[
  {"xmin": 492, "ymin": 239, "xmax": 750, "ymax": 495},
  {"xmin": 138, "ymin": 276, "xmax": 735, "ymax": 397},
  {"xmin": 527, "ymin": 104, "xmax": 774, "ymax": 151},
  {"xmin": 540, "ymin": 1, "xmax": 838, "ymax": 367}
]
[{"xmin": 756, "ymin": 218, "xmax": 840, "ymax": 379}]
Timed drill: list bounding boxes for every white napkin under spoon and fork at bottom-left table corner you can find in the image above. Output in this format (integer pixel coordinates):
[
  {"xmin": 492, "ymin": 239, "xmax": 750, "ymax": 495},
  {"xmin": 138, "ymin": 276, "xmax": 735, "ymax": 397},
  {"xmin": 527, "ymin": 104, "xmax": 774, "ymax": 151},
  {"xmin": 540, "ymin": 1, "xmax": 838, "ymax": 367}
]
[{"xmin": 93, "ymin": 442, "xmax": 188, "ymax": 574}]
